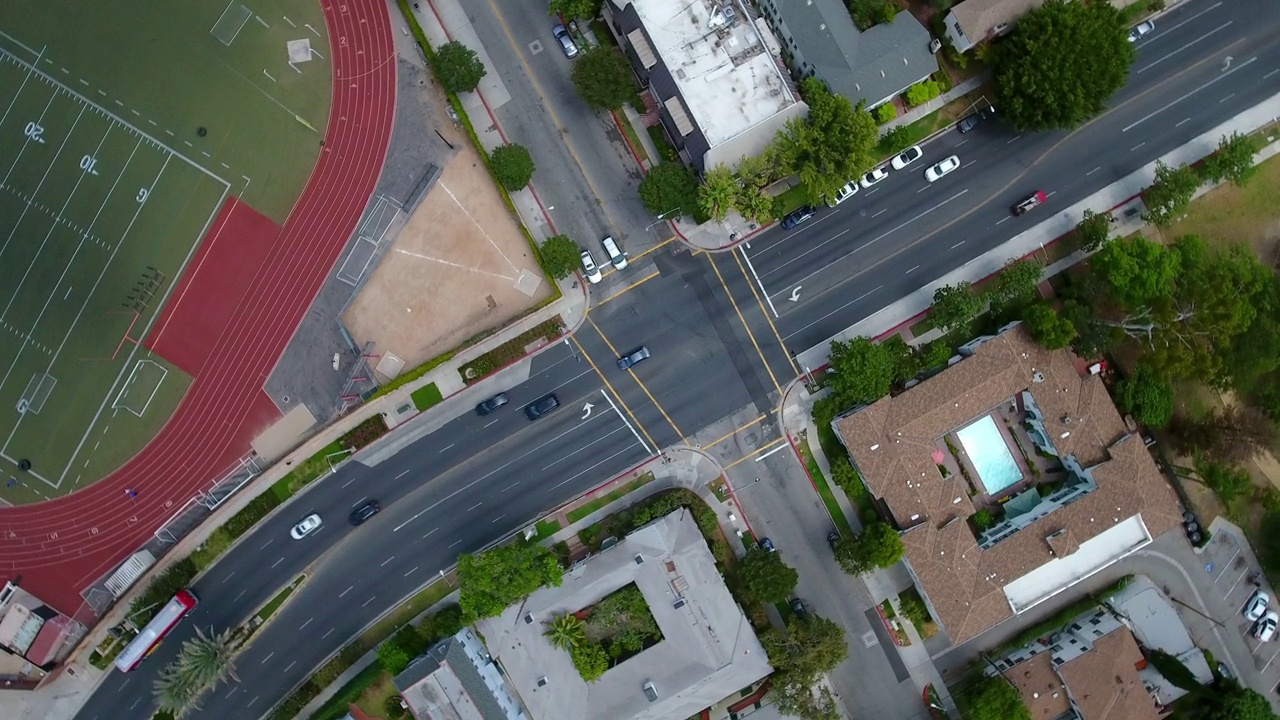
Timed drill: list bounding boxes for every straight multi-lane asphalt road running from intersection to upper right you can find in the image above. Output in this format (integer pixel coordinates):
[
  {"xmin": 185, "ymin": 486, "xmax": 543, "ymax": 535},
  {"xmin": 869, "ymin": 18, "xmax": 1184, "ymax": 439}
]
[{"xmin": 742, "ymin": 0, "xmax": 1280, "ymax": 352}]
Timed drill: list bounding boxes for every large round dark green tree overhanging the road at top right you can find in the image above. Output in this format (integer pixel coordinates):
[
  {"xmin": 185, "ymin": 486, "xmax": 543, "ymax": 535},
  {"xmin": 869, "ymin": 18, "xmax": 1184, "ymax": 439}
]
[{"xmin": 996, "ymin": 0, "xmax": 1135, "ymax": 131}]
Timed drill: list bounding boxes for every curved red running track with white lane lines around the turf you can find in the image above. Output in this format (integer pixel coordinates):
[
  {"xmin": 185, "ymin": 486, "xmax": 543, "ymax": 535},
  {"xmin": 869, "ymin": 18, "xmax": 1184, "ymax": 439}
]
[{"xmin": 0, "ymin": 0, "xmax": 396, "ymax": 618}]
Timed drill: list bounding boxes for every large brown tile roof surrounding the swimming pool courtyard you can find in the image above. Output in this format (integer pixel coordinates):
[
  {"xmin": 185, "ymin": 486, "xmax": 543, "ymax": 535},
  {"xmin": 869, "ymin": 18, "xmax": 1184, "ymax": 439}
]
[{"xmin": 837, "ymin": 328, "xmax": 1180, "ymax": 643}]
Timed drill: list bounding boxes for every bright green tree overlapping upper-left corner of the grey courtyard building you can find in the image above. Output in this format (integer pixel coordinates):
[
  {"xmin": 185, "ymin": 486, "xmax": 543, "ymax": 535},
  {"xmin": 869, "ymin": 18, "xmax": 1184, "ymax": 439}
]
[{"xmin": 458, "ymin": 542, "xmax": 564, "ymax": 623}]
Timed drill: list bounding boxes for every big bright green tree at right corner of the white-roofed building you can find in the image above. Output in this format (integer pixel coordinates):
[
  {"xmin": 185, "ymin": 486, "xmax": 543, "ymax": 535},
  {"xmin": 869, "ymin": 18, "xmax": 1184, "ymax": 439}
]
[{"xmin": 781, "ymin": 77, "xmax": 879, "ymax": 202}]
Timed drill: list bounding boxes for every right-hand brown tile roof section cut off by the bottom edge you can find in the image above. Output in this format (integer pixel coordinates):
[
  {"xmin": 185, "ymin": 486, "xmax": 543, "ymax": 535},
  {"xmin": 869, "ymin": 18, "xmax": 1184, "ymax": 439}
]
[{"xmin": 1054, "ymin": 628, "xmax": 1160, "ymax": 720}]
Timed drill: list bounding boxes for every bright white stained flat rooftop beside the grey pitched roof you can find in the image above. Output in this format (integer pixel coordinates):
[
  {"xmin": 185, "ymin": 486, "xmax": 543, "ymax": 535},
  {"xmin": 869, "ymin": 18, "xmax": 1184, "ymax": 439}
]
[{"xmin": 618, "ymin": 0, "xmax": 800, "ymax": 149}]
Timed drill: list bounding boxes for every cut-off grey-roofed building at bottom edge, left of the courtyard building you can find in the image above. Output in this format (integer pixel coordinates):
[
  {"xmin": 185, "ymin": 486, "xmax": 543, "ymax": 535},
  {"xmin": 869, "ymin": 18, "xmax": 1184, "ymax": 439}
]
[{"xmin": 394, "ymin": 628, "xmax": 529, "ymax": 720}]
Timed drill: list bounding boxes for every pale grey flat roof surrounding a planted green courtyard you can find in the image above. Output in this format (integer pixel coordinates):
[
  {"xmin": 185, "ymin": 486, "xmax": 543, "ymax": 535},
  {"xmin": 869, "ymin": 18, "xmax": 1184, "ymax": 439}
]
[{"xmin": 476, "ymin": 510, "xmax": 772, "ymax": 720}]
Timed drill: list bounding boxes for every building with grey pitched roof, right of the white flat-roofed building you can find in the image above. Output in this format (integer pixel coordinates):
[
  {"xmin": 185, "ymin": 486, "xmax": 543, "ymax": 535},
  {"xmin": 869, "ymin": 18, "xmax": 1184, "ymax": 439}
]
[{"xmin": 760, "ymin": 0, "xmax": 938, "ymax": 108}]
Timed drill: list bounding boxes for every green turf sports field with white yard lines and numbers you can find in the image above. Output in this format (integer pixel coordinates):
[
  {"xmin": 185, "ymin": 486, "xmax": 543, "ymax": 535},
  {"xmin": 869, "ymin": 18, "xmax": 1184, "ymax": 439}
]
[{"xmin": 0, "ymin": 0, "xmax": 330, "ymax": 502}]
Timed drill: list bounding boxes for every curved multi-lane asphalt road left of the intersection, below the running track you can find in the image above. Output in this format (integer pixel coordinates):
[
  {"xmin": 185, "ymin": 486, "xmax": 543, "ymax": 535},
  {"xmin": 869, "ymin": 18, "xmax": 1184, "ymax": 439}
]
[{"xmin": 78, "ymin": 346, "xmax": 650, "ymax": 720}]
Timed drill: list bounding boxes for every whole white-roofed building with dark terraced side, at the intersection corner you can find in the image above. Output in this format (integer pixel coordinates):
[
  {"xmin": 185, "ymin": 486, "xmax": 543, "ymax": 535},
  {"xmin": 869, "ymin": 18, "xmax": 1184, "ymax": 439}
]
[{"xmin": 604, "ymin": 0, "xmax": 809, "ymax": 172}]
